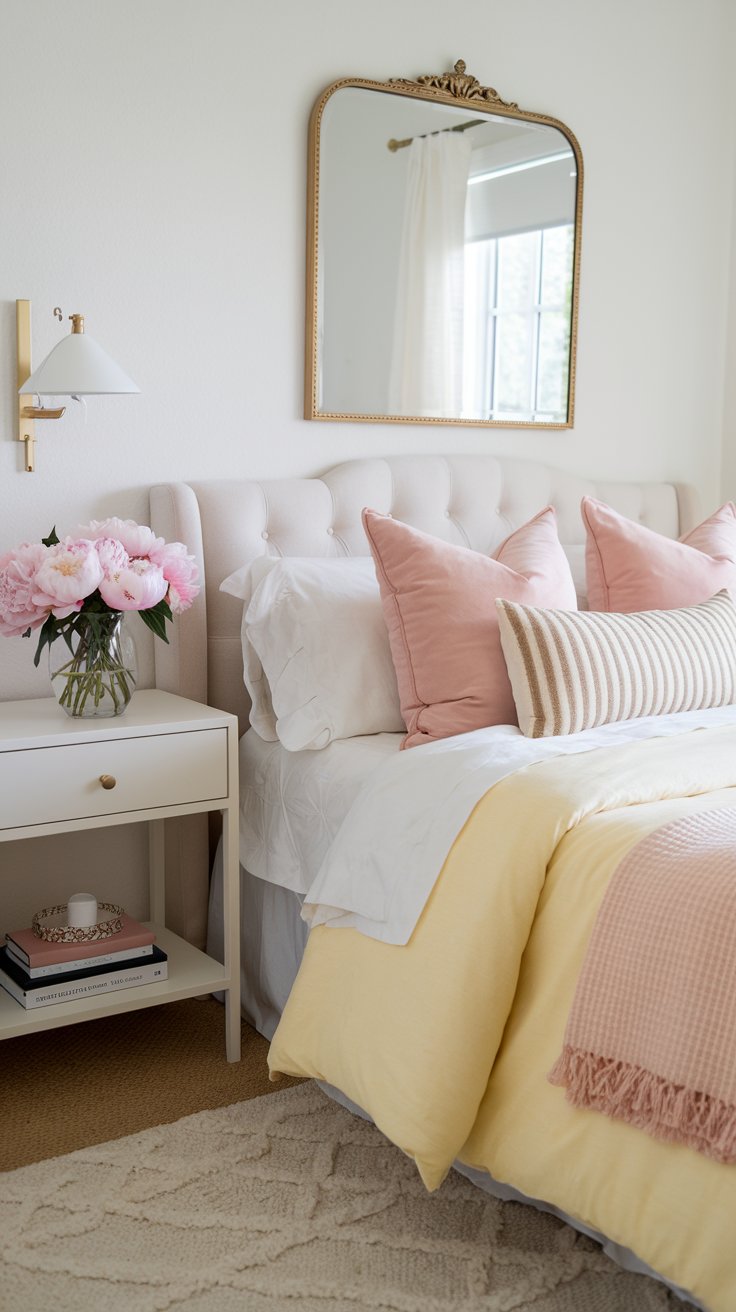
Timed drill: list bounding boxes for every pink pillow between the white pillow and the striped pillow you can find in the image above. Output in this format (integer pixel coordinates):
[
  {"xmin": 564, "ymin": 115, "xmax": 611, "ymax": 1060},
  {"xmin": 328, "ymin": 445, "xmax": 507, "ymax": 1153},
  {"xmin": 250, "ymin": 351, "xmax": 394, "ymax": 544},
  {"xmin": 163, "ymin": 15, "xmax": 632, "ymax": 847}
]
[{"xmin": 363, "ymin": 506, "xmax": 577, "ymax": 747}]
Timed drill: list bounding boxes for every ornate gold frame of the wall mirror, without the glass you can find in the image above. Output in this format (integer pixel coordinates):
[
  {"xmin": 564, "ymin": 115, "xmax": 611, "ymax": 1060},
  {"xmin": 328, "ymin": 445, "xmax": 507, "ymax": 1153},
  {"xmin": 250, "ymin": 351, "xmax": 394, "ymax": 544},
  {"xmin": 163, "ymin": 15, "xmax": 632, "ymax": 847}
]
[{"xmin": 304, "ymin": 59, "xmax": 583, "ymax": 429}]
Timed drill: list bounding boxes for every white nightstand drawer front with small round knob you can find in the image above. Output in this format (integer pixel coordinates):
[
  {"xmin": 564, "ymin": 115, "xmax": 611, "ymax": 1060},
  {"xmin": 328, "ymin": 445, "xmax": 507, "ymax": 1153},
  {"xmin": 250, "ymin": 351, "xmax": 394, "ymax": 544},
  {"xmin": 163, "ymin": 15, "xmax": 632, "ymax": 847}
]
[{"xmin": 0, "ymin": 728, "xmax": 228, "ymax": 829}]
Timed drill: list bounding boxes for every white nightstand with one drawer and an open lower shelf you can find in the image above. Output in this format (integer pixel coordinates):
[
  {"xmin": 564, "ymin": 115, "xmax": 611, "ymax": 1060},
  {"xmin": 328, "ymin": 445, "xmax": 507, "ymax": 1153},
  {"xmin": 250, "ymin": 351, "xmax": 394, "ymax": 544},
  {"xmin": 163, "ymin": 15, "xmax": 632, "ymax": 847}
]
[{"xmin": 0, "ymin": 689, "xmax": 240, "ymax": 1061}]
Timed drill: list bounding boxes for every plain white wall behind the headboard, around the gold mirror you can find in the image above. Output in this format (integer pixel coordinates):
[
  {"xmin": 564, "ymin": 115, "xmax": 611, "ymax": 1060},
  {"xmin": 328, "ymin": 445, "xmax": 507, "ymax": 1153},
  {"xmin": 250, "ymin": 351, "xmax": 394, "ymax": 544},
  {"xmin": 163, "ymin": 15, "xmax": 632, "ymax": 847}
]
[{"xmin": 0, "ymin": 0, "xmax": 736, "ymax": 913}]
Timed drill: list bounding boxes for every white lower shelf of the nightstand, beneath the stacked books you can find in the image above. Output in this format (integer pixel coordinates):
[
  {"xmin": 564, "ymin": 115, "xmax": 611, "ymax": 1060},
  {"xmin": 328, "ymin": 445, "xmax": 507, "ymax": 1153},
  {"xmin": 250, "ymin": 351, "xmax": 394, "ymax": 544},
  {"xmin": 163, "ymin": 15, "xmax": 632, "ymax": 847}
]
[{"xmin": 0, "ymin": 922, "xmax": 228, "ymax": 1039}]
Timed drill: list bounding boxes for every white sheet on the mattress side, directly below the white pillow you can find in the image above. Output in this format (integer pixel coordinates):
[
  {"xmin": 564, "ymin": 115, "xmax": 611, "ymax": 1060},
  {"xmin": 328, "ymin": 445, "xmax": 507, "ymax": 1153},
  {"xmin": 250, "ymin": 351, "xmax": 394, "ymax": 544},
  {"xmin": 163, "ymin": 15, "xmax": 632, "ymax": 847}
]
[{"xmin": 239, "ymin": 728, "xmax": 404, "ymax": 893}]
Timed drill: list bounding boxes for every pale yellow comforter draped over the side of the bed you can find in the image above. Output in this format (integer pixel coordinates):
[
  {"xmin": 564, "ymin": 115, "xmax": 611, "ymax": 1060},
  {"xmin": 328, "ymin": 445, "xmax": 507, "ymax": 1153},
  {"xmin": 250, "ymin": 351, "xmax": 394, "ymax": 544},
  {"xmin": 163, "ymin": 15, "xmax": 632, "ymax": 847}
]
[{"xmin": 269, "ymin": 727, "xmax": 736, "ymax": 1312}]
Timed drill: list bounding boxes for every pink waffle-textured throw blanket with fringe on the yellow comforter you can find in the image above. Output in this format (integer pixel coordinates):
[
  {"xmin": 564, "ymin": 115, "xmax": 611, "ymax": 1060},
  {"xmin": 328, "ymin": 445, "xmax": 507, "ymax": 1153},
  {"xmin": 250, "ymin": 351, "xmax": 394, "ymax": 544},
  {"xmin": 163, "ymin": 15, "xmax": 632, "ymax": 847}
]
[{"xmin": 548, "ymin": 808, "xmax": 736, "ymax": 1162}]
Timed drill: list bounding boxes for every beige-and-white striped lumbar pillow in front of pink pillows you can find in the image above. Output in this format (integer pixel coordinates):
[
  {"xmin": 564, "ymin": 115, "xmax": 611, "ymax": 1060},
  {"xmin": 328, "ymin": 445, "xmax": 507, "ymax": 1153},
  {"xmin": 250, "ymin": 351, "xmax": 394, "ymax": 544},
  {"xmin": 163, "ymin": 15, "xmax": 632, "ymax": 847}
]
[{"xmin": 496, "ymin": 592, "xmax": 736, "ymax": 737}]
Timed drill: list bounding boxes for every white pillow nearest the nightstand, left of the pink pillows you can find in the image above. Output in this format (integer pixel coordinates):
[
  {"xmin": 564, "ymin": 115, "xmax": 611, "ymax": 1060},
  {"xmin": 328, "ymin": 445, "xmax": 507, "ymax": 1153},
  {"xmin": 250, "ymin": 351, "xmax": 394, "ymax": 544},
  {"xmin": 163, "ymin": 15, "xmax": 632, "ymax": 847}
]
[{"xmin": 220, "ymin": 556, "xmax": 405, "ymax": 752}]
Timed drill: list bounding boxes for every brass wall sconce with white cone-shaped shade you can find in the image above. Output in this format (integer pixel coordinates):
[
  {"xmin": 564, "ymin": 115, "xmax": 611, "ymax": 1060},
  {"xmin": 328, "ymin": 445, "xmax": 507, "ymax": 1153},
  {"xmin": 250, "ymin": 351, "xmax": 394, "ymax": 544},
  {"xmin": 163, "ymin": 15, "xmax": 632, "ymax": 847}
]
[{"xmin": 16, "ymin": 300, "xmax": 140, "ymax": 474}]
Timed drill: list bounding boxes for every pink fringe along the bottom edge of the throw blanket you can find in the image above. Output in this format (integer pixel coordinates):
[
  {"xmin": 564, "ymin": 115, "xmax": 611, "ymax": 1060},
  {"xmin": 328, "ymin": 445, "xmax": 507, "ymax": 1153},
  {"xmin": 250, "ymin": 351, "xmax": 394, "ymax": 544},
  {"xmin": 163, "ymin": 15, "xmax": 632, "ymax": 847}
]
[{"xmin": 547, "ymin": 1044, "xmax": 736, "ymax": 1164}]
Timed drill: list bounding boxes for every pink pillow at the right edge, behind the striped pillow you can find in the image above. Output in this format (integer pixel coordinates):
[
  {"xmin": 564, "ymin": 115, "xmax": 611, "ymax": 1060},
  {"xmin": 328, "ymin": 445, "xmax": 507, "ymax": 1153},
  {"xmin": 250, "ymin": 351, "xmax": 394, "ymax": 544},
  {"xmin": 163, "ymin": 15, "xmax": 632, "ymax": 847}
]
[{"xmin": 581, "ymin": 496, "xmax": 736, "ymax": 613}]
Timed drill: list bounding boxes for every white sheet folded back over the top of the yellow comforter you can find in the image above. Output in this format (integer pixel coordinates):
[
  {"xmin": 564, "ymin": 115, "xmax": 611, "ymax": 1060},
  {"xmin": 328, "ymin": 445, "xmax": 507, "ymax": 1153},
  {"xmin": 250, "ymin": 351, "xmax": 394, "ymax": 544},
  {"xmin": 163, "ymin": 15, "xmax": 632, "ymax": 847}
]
[{"xmin": 302, "ymin": 706, "xmax": 736, "ymax": 943}]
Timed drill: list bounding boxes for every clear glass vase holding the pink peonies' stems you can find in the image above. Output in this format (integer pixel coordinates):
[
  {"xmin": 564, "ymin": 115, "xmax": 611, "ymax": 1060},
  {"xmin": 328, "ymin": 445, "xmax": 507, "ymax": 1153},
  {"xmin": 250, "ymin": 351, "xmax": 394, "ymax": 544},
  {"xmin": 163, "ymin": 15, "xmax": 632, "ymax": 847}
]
[{"xmin": 49, "ymin": 610, "xmax": 138, "ymax": 719}]
